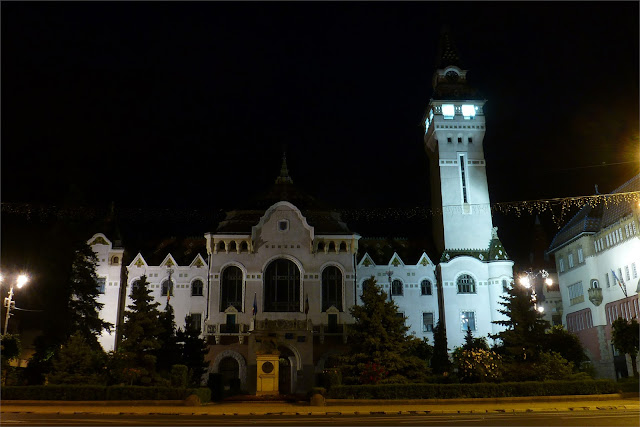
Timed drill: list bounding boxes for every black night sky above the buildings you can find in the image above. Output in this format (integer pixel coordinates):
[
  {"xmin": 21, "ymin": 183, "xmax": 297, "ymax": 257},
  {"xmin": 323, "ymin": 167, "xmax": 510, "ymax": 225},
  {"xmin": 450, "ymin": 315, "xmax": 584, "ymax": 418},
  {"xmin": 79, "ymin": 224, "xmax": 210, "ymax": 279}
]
[{"xmin": 1, "ymin": 2, "xmax": 640, "ymax": 266}]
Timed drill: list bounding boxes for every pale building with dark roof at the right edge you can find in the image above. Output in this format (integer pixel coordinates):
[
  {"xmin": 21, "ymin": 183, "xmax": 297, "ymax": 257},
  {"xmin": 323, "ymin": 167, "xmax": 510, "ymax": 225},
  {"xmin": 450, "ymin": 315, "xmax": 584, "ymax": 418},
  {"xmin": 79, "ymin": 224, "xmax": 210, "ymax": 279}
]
[{"xmin": 548, "ymin": 175, "xmax": 640, "ymax": 378}]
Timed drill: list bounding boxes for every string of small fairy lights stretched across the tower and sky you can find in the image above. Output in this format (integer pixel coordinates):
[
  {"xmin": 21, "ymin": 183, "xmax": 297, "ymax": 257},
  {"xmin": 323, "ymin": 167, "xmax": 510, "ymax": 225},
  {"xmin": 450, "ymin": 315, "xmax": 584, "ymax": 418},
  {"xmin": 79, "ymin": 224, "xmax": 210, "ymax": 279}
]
[{"xmin": 1, "ymin": 191, "xmax": 640, "ymax": 228}]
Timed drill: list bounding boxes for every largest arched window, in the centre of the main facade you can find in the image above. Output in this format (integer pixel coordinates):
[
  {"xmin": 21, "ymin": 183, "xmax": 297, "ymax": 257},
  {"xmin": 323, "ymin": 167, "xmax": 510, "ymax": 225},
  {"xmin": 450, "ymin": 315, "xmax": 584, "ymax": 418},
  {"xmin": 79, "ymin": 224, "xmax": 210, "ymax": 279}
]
[{"xmin": 264, "ymin": 258, "xmax": 300, "ymax": 311}]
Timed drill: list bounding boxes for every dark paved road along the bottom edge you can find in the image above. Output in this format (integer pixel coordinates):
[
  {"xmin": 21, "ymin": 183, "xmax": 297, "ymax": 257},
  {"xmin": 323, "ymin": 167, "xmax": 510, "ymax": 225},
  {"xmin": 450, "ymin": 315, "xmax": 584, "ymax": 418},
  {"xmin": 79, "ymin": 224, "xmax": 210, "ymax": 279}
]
[{"xmin": 1, "ymin": 409, "xmax": 640, "ymax": 427}]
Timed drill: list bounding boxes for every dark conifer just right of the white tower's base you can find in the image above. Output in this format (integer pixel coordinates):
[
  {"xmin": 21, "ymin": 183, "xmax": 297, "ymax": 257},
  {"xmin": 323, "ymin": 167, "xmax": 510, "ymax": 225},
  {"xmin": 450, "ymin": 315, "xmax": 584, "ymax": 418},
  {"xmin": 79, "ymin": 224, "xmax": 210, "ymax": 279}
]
[{"xmin": 491, "ymin": 286, "xmax": 549, "ymax": 363}]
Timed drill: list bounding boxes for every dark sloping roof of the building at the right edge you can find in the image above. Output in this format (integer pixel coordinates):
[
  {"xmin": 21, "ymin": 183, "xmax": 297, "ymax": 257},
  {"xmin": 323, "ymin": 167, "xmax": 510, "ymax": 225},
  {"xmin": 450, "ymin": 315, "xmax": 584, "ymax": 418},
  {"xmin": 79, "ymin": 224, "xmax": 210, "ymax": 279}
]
[{"xmin": 547, "ymin": 174, "xmax": 640, "ymax": 252}]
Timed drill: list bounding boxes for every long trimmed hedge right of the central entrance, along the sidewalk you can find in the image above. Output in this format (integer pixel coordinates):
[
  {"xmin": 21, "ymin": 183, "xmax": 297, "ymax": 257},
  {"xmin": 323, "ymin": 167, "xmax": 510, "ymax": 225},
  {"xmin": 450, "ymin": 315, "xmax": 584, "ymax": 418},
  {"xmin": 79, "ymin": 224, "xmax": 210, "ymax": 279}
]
[{"xmin": 327, "ymin": 380, "xmax": 619, "ymax": 399}]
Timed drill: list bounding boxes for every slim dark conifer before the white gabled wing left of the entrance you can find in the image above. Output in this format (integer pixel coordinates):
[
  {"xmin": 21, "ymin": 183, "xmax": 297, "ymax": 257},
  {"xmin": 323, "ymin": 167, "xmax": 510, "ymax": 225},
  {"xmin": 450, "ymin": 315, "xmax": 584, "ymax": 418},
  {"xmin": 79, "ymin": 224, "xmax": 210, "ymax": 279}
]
[{"xmin": 121, "ymin": 276, "xmax": 163, "ymax": 385}]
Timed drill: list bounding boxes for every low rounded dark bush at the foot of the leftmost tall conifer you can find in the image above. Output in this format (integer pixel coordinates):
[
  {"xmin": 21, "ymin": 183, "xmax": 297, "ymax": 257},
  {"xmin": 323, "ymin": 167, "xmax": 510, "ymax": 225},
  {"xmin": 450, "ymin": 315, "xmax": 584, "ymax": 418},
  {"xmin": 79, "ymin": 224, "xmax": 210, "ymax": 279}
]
[{"xmin": 48, "ymin": 331, "xmax": 106, "ymax": 384}]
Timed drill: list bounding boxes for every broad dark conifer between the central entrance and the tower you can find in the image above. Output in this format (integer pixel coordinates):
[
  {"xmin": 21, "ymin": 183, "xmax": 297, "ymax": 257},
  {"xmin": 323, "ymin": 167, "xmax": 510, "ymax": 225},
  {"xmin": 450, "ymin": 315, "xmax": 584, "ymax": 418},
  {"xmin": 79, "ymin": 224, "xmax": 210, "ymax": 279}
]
[{"xmin": 341, "ymin": 277, "xmax": 429, "ymax": 383}]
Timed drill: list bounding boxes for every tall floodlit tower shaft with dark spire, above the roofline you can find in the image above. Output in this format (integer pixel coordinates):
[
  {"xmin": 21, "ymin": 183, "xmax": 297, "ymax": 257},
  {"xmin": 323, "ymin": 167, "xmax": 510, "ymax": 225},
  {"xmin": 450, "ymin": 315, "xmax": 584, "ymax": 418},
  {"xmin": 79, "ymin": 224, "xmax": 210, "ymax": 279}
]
[{"xmin": 423, "ymin": 30, "xmax": 493, "ymax": 253}]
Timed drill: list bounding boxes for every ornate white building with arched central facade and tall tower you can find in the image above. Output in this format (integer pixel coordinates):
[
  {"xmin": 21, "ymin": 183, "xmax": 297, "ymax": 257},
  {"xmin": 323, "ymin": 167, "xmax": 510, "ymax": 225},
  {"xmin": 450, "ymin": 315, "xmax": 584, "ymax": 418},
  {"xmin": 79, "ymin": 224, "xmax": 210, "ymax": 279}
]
[{"xmin": 89, "ymin": 34, "xmax": 513, "ymax": 392}]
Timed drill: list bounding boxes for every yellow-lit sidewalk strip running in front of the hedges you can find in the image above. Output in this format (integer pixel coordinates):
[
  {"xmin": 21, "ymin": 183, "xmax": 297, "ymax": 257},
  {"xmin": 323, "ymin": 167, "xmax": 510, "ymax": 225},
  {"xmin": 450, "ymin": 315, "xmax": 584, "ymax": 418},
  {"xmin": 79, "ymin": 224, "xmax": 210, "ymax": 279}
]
[{"xmin": 0, "ymin": 394, "xmax": 640, "ymax": 416}]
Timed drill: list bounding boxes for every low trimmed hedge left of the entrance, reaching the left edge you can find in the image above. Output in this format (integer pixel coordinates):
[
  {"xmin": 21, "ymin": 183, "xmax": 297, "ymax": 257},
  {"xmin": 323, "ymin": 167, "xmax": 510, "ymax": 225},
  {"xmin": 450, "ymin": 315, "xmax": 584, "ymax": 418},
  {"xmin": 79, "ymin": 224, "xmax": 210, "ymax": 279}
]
[{"xmin": 2, "ymin": 385, "xmax": 211, "ymax": 403}]
